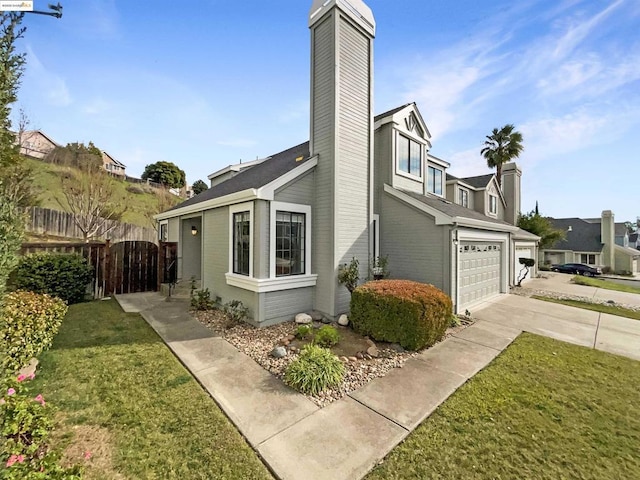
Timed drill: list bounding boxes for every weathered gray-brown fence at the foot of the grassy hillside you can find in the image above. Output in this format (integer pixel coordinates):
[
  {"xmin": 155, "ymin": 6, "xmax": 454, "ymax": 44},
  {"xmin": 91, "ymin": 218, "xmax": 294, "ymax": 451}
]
[{"xmin": 26, "ymin": 207, "xmax": 158, "ymax": 243}]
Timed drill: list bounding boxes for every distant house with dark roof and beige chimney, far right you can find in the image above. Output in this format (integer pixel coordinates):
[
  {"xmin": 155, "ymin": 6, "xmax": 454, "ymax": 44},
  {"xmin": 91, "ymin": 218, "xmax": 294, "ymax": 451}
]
[{"xmin": 540, "ymin": 210, "xmax": 640, "ymax": 274}]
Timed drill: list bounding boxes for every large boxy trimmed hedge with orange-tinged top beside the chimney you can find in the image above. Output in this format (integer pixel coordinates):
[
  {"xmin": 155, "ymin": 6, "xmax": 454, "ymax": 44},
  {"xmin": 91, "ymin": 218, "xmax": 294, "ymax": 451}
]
[{"xmin": 350, "ymin": 280, "xmax": 453, "ymax": 350}]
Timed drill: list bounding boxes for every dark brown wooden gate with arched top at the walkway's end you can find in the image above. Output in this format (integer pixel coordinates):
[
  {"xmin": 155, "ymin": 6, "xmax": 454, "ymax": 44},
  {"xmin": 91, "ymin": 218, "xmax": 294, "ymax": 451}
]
[{"xmin": 107, "ymin": 241, "xmax": 158, "ymax": 294}]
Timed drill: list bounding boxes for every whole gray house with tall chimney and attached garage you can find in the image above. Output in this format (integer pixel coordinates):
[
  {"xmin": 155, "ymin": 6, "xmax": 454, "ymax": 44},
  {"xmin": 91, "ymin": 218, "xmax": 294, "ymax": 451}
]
[{"xmin": 156, "ymin": 0, "xmax": 539, "ymax": 325}]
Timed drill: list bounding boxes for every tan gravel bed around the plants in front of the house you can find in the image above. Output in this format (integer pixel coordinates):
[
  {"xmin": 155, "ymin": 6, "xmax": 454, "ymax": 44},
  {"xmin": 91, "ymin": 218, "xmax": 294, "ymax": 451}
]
[{"xmin": 193, "ymin": 310, "xmax": 470, "ymax": 407}]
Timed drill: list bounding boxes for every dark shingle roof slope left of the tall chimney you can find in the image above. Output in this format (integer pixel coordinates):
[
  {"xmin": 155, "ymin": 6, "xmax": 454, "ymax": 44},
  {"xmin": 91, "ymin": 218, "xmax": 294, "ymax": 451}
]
[{"xmin": 169, "ymin": 142, "xmax": 310, "ymax": 211}]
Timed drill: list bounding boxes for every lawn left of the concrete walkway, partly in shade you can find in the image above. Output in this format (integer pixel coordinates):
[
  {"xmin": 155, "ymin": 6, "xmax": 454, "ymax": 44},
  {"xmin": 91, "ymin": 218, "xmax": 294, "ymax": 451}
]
[{"xmin": 34, "ymin": 300, "xmax": 272, "ymax": 479}]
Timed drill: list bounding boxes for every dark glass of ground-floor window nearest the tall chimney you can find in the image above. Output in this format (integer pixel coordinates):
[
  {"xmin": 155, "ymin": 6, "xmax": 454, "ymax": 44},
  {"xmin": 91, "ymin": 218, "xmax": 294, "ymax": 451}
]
[{"xmin": 275, "ymin": 212, "xmax": 305, "ymax": 277}]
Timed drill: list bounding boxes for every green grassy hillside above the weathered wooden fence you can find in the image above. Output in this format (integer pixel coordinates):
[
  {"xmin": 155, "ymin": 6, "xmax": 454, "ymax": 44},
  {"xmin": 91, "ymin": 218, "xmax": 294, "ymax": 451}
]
[{"xmin": 25, "ymin": 158, "xmax": 181, "ymax": 227}]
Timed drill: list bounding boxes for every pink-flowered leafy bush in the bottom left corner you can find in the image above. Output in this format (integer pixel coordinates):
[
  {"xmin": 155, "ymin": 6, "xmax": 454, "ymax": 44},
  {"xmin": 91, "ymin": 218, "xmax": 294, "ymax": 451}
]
[{"xmin": 0, "ymin": 375, "xmax": 82, "ymax": 480}]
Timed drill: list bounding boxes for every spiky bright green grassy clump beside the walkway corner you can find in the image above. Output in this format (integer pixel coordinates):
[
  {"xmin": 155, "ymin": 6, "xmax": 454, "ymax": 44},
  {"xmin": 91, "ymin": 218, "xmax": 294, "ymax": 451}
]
[{"xmin": 284, "ymin": 344, "xmax": 345, "ymax": 395}]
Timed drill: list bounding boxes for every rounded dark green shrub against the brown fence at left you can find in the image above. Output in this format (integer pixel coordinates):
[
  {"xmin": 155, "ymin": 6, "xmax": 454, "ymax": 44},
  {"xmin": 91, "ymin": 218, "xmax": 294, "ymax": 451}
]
[{"xmin": 13, "ymin": 253, "xmax": 93, "ymax": 304}]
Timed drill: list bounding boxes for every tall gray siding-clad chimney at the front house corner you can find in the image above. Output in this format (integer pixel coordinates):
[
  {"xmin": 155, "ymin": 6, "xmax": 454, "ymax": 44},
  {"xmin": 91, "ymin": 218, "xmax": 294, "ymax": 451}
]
[{"xmin": 309, "ymin": 0, "xmax": 375, "ymax": 317}]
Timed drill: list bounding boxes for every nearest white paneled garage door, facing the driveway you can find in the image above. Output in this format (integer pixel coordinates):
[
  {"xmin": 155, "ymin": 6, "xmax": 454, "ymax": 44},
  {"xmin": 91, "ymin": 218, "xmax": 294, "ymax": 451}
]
[{"xmin": 458, "ymin": 242, "xmax": 502, "ymax": 310}]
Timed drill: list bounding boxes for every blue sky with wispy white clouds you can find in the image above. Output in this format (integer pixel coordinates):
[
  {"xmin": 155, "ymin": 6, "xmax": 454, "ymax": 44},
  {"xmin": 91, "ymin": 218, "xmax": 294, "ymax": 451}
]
[{"xmin": 13, "ymin": 0, "xmax": 640, "ymax": 221}]
